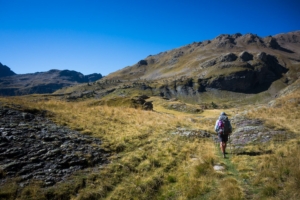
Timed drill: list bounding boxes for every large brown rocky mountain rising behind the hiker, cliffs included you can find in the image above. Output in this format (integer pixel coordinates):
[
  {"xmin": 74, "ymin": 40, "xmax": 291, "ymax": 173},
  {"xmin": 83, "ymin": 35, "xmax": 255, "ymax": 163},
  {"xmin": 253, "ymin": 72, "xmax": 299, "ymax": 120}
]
[{"xmin": 57, "ymin": 31, "xmax": 300, "ymax": 102}]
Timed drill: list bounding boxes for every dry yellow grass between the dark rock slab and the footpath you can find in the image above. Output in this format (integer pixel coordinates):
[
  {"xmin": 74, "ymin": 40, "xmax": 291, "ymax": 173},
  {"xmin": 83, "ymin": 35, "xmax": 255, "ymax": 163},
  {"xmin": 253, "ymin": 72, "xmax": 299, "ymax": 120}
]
[{"xmin": 1, "ymin": 97, "xmax": 225, "ymax": 199}]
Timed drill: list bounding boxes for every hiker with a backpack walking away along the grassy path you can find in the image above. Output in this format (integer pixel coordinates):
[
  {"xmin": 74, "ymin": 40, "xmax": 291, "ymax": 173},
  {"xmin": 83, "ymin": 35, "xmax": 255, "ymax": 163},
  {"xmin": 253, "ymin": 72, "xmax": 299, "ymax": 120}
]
[{"xmin": 215, "ymin": 112, "xmax": 232, "ymax": 158}]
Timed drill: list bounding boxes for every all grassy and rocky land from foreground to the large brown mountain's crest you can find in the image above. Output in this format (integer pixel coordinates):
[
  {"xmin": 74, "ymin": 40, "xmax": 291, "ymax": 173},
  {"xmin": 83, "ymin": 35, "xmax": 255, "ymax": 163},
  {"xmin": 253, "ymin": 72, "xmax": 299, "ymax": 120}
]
[{"xmin": 0, "ymin": 32, "xmax": 300, "ymax": 200}]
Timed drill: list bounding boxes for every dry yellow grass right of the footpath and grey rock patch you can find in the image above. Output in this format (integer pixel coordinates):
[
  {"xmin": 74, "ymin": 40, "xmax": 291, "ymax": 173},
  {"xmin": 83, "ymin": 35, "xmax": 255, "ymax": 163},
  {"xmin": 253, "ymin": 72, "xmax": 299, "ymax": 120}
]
[{"xmin": 232, "ymin": 91, "xmax": 300, "ymax": 199}]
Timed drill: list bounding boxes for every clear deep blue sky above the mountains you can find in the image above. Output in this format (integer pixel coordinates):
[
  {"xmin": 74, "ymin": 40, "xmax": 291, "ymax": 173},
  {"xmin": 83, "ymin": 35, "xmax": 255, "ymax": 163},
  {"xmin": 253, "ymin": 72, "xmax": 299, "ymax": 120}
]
[{"xmin": 0, "ymin": 0, "xmax": 300, "ymax": 75}]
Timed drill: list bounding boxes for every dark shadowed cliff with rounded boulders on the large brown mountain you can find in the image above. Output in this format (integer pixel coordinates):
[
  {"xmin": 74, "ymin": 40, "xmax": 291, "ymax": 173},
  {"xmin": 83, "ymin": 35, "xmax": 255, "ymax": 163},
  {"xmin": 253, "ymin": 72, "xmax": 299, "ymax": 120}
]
[{"xmin": 157, "ymin": 51, "xmax": 288, "ymax": 98}]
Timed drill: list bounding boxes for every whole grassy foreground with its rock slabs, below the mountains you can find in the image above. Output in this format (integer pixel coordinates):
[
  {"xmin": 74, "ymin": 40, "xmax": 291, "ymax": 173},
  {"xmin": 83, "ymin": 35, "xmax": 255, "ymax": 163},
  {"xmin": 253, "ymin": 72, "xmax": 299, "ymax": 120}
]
[{"xmin": 0, "ymin": 84, "xmax": 300, "ymax": 200}]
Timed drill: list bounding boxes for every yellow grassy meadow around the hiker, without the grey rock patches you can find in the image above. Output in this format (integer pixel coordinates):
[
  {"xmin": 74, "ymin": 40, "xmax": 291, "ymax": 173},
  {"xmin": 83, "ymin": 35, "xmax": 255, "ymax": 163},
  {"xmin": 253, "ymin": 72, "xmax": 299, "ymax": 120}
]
[{"xmin": 0, "ymin": 88, "xmax": 300, "ymax": 200}]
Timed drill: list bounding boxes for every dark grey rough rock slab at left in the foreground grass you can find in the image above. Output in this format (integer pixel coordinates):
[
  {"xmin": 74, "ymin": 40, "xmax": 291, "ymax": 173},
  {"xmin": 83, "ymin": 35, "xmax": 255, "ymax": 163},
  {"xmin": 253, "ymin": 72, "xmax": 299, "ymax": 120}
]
[{"xmin": 0, "ymin": 107, "xmax": 109, "ymax": 186}]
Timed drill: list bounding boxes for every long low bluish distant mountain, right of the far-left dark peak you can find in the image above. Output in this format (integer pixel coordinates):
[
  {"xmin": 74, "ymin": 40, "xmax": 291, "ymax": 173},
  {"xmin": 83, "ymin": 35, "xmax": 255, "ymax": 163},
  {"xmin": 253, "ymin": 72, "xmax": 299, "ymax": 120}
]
[{"xmin": 0, "ymin": 70, "xmax": 102, "ymax": 96}]
